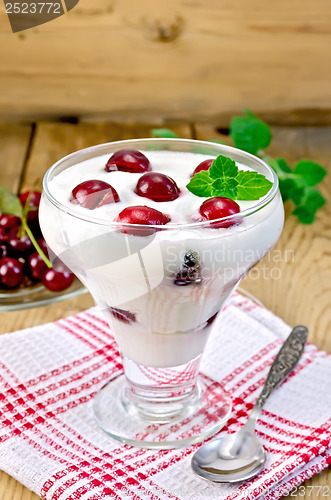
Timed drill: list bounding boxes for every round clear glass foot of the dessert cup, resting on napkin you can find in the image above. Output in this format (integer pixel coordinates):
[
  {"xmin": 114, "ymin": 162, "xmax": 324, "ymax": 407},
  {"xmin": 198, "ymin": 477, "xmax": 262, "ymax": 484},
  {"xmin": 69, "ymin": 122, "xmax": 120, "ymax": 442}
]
[{"xmin": 92, "ymin": 375, "xmax": 232, "ymax": 449}]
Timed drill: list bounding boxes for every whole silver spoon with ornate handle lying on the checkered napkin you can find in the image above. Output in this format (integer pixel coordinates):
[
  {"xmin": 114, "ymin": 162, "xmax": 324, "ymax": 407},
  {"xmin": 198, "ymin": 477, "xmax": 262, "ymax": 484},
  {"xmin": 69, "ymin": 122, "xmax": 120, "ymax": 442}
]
[{"xmin": 191, "ymin": 325, "xmax": 308, "ymax": 483}]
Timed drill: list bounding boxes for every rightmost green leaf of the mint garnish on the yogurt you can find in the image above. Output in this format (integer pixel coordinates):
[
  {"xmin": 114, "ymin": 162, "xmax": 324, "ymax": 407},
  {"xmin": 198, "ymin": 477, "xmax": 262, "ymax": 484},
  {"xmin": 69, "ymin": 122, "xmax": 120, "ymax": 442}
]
[{"xmin": 236, "ymin": 170, "xmax": 272, "ymax": 200}]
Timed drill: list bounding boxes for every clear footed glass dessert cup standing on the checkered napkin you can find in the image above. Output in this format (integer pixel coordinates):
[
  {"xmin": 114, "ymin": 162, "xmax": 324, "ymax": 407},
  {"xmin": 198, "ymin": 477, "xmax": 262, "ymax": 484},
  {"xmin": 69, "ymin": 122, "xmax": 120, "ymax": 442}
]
[{"xmin": 39, "ymin": 139, "xmax": 284, "ymax": 449}]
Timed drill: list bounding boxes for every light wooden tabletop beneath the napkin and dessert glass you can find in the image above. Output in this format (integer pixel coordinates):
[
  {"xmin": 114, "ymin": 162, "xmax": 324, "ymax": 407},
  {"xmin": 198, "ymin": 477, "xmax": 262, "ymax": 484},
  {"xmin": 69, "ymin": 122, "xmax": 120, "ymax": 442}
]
[{"xmin": 0, "ymin": 122, "xmax": 331, "ymax": 500}]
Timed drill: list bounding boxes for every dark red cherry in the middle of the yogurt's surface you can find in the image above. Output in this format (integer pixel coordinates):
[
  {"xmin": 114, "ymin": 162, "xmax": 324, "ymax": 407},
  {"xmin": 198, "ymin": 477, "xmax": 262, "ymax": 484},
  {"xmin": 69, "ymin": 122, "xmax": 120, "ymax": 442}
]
[{"xmin": 135, "ymin": 172, "xmax": 180, "ymax": 201}]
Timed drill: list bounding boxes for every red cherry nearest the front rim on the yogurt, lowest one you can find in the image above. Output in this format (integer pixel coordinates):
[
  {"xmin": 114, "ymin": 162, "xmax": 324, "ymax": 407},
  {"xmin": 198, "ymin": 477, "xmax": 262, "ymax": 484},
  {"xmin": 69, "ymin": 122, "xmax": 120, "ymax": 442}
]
[{"xmin": 116, "ymin": 205, "xmax": 170, "ymax": 236}]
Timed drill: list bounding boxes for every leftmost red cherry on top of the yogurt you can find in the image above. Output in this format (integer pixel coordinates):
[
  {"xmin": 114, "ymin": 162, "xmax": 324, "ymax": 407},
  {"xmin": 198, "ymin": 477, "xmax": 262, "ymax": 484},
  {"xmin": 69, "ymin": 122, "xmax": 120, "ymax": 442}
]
[{"xmin": 70, "ymin": 179, "xmax": 120, "ymax": 210}]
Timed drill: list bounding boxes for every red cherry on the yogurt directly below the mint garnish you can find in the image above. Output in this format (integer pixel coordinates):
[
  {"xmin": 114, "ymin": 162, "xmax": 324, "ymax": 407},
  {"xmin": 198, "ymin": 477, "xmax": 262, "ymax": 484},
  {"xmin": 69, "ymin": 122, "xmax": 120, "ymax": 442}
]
[{"xmin": 199, "ymin": 196, "xmax": 240, "ymax": 228}]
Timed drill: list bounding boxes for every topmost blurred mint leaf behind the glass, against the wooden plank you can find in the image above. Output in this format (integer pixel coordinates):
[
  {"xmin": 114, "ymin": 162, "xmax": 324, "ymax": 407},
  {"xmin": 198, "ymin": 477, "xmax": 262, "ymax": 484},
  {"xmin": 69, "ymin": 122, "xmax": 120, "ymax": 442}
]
[{"xmin": 230, "ymin": 111, "xmax": 271, "ymax": 154}]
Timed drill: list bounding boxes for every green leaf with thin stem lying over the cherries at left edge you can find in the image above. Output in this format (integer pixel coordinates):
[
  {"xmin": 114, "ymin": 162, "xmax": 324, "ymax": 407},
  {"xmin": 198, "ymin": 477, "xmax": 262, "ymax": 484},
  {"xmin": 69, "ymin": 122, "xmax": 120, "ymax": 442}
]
[{"xmin": 0, "ymin": 186, "xmax": 53, "ymax": 268}]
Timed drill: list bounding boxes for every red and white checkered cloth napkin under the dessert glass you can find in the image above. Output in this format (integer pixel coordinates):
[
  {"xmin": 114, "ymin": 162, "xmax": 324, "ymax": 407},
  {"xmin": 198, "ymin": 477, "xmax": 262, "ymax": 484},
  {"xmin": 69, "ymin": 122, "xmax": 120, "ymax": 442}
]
[{"xmin": 0, "ymin": 294, "xmax": 331, "ymax": 500}]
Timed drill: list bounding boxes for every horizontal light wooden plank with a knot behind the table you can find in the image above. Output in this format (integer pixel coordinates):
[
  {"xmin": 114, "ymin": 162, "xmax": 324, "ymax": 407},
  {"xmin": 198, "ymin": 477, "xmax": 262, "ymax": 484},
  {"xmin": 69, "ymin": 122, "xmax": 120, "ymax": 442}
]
[{"xmin": 0, "ymin": 0, "xmax": 331, "ymax": 124}]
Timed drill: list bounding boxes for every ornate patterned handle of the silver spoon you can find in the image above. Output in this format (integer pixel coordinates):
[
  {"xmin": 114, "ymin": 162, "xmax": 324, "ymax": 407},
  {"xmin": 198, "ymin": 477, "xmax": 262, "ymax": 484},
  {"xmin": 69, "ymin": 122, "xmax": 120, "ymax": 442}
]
[{"xmin": 254, "ymin": 325, "xmax": 308, "ymax": 413}]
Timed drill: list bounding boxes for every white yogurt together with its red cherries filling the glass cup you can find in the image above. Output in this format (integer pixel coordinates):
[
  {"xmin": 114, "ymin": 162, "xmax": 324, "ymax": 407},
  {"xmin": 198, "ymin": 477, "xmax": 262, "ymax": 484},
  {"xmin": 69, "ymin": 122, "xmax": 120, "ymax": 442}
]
[{"xmin": 40, "ymin": 146, "xmax": 284, "ymax": 367}]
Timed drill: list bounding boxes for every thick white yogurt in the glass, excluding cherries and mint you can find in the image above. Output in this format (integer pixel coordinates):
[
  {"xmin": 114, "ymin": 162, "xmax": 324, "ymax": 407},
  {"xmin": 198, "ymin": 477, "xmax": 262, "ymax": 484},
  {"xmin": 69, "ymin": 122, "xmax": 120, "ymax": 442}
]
[{"xmin": 40, "ymin": 151, "xmax": 284, "ymax": 367}]
